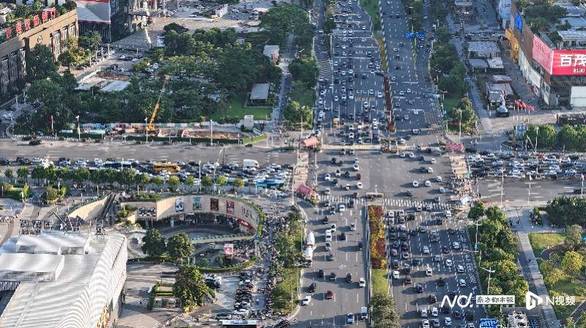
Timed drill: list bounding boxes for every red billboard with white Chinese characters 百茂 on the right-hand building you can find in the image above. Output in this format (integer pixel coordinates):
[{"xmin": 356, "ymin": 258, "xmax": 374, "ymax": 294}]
[{"xmin": 533, "ymin": 36, "xmax": 586, "ymax": 76}]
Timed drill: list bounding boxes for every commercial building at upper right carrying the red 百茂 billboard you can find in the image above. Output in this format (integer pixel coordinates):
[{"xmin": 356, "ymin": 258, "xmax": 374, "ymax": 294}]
[{"xmin": 505, "ymin": 2, "xmax": 586, "ymax": 107}]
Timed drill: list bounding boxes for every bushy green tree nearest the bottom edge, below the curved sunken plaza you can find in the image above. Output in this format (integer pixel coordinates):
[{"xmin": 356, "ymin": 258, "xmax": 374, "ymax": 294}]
[{"xmin": 173, "ymin": 265, "xmax": 215, "ymax": 311}]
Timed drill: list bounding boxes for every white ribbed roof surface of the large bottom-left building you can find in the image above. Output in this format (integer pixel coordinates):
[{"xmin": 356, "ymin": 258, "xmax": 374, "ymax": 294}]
[{"xmin": 0, "ymin": 232, "xmax": 127, "ymax": 328}]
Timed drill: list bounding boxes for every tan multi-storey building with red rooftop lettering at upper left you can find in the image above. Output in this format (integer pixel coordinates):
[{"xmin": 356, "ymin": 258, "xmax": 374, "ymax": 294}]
[{"xmin": 0, "ymin": 8, "xmax": 78, "ymax": 99}]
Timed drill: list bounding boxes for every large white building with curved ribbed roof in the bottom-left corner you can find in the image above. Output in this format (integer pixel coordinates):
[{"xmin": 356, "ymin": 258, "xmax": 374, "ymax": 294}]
[{"xmin": 0, "ymin": 232, "xmax": 128, "ymax": 328}]
